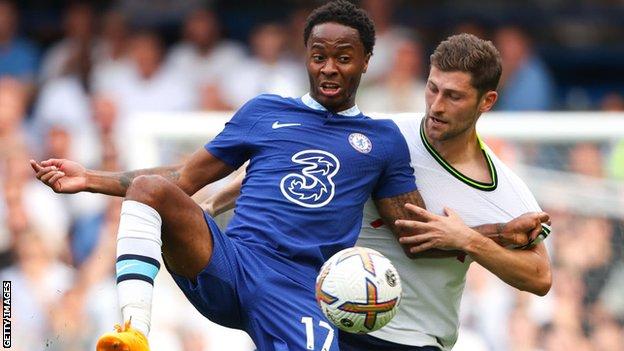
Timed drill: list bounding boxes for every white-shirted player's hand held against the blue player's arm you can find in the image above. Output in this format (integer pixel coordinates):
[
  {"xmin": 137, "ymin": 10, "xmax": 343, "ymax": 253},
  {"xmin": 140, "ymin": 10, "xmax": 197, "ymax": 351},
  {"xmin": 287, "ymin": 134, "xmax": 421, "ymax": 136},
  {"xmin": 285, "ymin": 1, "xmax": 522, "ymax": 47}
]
[{"xmin": 395, "ymin": 204, "xmax": 472, "ymax": 254}]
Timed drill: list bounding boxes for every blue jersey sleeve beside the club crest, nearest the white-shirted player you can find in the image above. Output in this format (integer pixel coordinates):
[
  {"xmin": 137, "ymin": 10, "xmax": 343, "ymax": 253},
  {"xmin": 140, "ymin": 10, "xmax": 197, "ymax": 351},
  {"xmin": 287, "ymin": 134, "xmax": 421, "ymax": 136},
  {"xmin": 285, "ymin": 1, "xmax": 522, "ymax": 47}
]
[{"xmin": 373, "ymin": 121, "xmax": 417, "ymax": 199}]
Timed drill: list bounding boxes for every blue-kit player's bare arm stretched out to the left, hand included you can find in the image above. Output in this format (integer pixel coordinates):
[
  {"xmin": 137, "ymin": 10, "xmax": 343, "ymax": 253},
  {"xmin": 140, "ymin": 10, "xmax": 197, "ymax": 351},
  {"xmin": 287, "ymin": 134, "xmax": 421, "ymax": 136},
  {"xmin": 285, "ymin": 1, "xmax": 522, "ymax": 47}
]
[{"xmin": 30, "ymin": 148, "xmax": 233, "ymax": 197}]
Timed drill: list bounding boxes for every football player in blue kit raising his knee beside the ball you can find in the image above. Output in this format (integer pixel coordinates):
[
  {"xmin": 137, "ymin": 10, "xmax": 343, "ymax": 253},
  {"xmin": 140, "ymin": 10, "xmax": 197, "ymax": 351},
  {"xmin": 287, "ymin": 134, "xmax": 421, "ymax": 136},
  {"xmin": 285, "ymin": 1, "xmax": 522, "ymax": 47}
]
[{"xmin": 31, "ymin": 1, "xmax": 423, "ymax": 351}]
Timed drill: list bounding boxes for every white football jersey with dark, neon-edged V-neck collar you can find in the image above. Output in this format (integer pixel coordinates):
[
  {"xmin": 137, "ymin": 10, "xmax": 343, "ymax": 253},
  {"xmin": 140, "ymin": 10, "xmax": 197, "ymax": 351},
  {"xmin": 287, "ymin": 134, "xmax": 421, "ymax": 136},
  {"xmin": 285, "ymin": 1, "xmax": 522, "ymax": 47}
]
[{"xmin": 357, "ymin": 119, "xmax": 540, "ymax": 350}]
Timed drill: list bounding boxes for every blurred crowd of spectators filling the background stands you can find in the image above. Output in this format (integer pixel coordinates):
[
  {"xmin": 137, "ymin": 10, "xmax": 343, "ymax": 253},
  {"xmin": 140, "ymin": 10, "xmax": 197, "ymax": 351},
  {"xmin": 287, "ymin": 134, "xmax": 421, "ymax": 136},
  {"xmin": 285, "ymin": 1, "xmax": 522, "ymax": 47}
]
[{"xmin": 0, "ymin": 0, "xmax": 624, "ymax": 351}]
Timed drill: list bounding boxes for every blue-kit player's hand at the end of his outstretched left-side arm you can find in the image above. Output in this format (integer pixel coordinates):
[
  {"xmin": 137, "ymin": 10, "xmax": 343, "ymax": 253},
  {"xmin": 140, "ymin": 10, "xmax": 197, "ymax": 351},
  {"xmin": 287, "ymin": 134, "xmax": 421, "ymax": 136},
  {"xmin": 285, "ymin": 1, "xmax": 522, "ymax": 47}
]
[{"xmin": 30, "ymin": 158, "xmax": 87, "ymax": 194}]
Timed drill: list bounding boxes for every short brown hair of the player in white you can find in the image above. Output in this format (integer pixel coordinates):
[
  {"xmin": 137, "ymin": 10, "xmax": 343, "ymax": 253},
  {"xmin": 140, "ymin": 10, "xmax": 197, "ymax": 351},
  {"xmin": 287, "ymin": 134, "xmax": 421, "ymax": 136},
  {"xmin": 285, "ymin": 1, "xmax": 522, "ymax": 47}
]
[{"xmin": 430, "ymin": 33, "xmax": 503, "ymax": 95}]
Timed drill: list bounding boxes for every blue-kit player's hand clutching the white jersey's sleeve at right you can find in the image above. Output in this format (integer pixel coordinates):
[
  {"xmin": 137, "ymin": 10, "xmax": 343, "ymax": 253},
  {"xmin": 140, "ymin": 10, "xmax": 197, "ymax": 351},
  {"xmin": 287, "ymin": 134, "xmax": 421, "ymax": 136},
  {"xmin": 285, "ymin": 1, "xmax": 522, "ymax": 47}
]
[{"xmin": 500, "ymin": 212, "xmax": 550, "ymax": 246}]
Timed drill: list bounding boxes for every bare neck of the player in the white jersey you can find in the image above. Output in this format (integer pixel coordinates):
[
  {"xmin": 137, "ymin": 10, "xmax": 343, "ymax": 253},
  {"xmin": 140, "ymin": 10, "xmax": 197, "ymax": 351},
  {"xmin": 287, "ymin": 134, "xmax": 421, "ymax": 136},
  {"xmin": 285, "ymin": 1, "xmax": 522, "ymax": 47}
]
[{"xmin": 425, "ymin": 127, "xmax": 481, "ymax": 165}]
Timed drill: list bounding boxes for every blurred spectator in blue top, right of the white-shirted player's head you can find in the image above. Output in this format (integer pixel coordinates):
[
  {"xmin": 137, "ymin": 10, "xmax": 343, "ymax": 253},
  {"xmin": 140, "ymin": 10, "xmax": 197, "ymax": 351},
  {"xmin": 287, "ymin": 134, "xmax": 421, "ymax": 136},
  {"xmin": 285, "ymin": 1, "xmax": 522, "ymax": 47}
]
[{"xmin": 495, "ymin": 27, "xmax": 555, "ymax": 111}]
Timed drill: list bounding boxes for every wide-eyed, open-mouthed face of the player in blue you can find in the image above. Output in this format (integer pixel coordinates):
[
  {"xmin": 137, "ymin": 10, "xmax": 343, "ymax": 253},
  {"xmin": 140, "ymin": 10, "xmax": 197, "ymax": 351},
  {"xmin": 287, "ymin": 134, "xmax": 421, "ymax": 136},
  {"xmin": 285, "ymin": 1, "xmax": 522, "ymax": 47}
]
[{"xmin": 306, "ymin": 22, "xmax": 370, "ymax": 112}]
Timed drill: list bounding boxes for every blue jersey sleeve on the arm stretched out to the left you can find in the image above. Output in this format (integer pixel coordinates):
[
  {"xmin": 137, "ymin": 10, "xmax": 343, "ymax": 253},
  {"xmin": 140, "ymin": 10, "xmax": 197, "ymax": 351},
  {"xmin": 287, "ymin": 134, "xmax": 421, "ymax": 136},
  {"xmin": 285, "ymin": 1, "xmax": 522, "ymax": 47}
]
[{"xmin": 204, "ymin": 98, "xmax": 264, "ymax": 168}]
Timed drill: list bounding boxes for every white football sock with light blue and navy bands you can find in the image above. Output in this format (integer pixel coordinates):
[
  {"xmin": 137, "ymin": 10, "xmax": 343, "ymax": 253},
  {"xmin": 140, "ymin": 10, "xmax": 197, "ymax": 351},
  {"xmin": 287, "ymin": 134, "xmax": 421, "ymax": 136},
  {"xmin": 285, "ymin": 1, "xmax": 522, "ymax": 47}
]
[{"xmin": 116, "ymin": 200, "xmax": 162, "ymax": 336}]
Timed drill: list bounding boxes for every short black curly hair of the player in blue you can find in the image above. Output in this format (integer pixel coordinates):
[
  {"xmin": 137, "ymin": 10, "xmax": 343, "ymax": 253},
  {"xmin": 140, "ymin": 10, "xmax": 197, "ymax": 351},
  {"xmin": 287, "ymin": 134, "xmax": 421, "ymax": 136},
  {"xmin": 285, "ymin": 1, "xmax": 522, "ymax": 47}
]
[{"xmin": 303, "ymin": 0, "xmax": 375, "ymax": 54}]
